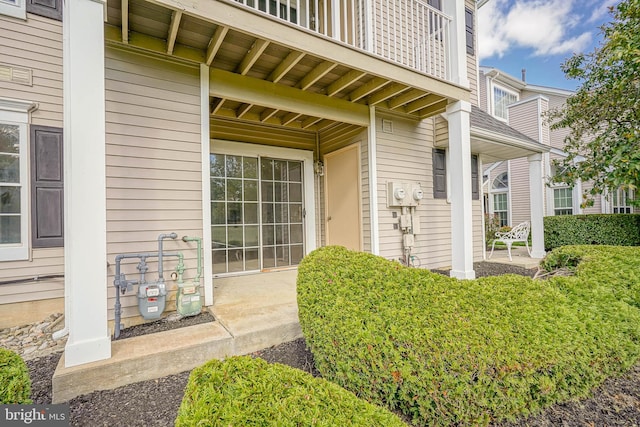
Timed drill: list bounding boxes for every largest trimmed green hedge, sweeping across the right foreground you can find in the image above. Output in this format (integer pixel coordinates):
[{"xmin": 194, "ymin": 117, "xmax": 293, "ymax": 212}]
[{"xmin": 298, "ymin": 247, "xmax": 640, "ymax": 426}]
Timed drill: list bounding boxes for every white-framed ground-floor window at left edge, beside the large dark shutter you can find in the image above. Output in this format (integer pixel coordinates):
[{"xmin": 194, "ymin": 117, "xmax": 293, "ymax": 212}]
[{"xmin": 0, "ymin": 98, "xmax": 32, "ymax": 261}]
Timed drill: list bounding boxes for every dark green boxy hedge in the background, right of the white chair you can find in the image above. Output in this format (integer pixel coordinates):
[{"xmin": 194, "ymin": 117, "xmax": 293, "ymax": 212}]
[{"xmin": 544, "ymin": 214, "xmax": 640, "ymax": 250}]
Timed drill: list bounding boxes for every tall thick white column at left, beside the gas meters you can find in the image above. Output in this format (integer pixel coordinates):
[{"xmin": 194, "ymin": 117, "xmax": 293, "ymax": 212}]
[{"xmin": 63, "ymin": 0, "xmax": 111, "ymax": 367}]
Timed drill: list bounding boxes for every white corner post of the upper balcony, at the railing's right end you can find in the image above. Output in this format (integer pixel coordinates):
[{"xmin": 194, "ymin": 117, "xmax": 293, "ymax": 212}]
[{"xmin": 442, "ymin": 0, "xmax": 469, "ymax": 87}]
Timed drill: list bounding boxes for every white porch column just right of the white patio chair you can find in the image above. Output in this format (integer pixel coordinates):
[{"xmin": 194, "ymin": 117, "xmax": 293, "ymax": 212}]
[{"xmin": 528, "ymin": 154, "xmax": 546, "ymax": 258}]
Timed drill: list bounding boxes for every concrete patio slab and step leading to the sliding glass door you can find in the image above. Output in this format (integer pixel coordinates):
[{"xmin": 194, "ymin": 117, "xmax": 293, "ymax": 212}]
[{"xmin": 52, "ymin": 270, "xmax": 302, "ymax": 403}]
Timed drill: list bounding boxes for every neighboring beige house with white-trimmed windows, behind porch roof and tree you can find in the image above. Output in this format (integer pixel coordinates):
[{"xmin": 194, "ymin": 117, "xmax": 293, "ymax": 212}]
[{"xmin": 479, "ymin": 66, "xmax": 634, "ymax": 225}]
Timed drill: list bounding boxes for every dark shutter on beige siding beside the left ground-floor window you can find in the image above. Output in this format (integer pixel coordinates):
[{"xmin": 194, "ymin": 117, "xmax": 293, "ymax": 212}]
[{"xmin": 30, "ymin": 126, "xmax": 64, "ymax": 248}]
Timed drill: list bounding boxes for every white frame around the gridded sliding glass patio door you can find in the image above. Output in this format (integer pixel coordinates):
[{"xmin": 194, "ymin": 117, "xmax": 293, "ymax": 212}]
[{"xmin": 209, "ymin": 139, "xmax": 317, "ymax": 277}]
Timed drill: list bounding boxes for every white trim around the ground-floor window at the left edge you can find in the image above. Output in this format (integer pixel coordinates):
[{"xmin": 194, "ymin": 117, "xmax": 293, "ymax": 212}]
[{"xmin": 0, "ymin": 98, "xmax": 36, "ymax": 261}]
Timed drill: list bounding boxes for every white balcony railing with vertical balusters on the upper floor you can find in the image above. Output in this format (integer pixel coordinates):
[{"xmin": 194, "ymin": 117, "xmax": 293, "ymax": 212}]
[{"xmin": 236, "ymin": 0, "xmax": 451, "ymax": 80}]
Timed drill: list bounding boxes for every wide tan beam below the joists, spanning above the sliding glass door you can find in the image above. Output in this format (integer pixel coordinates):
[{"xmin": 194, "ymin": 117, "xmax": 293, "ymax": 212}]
[{"xmin": 209, "ymin": 68, "xmax": 369, "ymax": 126}]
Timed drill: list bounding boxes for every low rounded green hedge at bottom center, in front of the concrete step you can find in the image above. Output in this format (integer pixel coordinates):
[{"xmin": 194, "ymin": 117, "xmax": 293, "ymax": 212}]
[{"xmin": 175, "ymin": 356, "xmax": 406, "ymax": 427}]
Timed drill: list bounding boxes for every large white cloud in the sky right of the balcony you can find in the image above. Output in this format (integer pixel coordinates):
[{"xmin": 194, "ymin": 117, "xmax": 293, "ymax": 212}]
[{"xmin": 478, "ymin": 0, "xmax": 592, "ymax": 60}]
